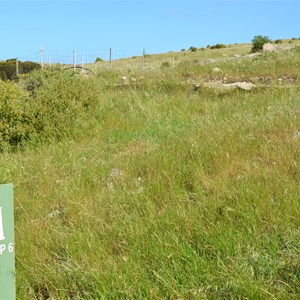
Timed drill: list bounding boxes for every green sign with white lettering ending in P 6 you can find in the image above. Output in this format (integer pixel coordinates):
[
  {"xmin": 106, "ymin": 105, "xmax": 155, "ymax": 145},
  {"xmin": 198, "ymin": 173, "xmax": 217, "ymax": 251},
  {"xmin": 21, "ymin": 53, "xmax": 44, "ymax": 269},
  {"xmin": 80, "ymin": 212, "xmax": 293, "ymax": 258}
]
[{"xmin": 0, "ymin": 184, "xmax": 16, "ymax": 300}]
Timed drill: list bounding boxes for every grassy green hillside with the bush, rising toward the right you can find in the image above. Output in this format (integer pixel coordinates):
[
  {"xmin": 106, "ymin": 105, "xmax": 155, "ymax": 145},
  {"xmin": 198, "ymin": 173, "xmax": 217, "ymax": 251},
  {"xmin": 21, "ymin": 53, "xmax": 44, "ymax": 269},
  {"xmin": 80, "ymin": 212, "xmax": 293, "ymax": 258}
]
[{"xmin": 0, "ymin": 41, "xmax": 300, "ymax": 299}]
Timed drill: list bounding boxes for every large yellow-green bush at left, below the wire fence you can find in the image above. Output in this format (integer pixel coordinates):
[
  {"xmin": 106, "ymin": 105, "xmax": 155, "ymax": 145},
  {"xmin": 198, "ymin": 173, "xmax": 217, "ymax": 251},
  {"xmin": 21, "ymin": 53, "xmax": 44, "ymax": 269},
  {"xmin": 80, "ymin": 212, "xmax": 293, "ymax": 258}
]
[{"xmin": 0, "ymin": 71, "xmax": 99, "ymax": 151}]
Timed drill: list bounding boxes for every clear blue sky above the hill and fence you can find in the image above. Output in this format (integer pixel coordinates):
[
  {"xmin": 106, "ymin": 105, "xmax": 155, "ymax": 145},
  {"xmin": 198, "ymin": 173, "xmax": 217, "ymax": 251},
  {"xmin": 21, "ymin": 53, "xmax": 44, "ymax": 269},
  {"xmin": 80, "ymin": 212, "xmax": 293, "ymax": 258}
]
[{"xmin": 0, "ymin": 0, "xmax": 300, "ymax": 60}]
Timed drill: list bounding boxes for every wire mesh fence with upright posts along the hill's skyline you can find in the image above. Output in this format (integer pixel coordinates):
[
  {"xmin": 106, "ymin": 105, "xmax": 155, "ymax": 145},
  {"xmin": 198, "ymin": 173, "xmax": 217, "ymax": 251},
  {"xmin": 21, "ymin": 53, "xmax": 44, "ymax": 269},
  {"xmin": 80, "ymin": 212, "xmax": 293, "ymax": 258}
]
[{"xmin": 17, "ymin": 48, "xmax": 189, "ymax": 75}]
